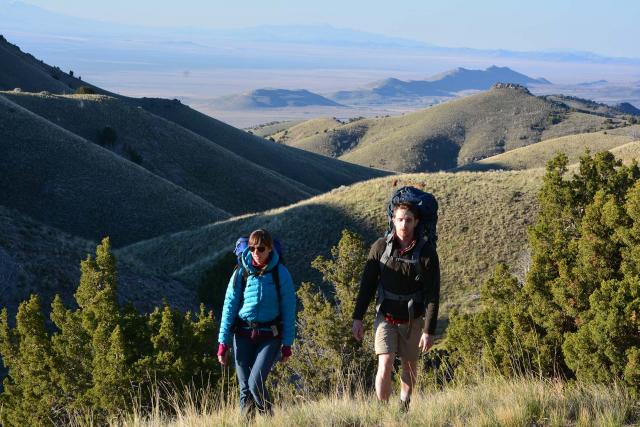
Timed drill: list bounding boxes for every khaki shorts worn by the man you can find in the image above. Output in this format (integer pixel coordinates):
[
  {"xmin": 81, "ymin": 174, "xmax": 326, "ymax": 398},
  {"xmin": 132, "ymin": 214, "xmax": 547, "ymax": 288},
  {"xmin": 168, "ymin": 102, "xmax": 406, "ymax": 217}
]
[{"xmin": 373, "ymin": 314, "xmax": 424, "ymax": 360}]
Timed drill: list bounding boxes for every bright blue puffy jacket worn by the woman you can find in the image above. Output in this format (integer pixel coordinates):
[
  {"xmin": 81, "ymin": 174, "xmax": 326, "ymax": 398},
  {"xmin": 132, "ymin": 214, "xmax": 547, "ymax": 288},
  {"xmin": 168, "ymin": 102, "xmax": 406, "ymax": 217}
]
[{"xmin": 218, "ymin": 248, "xmax": 296, "ymax": 345}]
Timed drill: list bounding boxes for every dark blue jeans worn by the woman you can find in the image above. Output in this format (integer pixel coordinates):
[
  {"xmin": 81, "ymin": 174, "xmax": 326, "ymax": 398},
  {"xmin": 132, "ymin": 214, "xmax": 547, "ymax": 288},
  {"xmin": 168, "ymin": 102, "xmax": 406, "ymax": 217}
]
[{"xmin": 233, "ymin": 334, "xmax": 282, "ymax": 414}]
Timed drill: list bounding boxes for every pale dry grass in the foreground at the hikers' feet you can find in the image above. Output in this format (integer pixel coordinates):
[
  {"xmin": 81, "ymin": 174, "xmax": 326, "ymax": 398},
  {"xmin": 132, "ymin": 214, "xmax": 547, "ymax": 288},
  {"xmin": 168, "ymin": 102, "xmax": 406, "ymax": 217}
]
[{"xmin": 74, "ymin": 378, "xmax": 640, "ymax": 427}]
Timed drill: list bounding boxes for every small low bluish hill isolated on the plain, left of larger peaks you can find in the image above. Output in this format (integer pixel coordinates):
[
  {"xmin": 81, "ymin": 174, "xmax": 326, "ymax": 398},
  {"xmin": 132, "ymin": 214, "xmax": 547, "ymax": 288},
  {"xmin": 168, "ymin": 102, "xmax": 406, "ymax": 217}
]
[{"xmin": 211, "ymin": 89, "xmax": 342, "ymax": 110}]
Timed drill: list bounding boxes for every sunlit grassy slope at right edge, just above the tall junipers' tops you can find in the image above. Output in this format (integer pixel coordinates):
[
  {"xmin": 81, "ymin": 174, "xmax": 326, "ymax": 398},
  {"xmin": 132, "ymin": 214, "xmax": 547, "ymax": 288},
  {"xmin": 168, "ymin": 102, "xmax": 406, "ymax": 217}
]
[{"xmin": 459, "ymin": 125, "xmax": 640, "ymax": 171}]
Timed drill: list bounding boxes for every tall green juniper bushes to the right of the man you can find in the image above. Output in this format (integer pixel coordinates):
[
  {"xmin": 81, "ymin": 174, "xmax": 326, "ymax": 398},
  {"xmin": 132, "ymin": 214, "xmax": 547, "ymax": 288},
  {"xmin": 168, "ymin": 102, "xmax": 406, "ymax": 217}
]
[{"xmin": 447, "ymin": 152, "xmax": 640, "ymax": 393}]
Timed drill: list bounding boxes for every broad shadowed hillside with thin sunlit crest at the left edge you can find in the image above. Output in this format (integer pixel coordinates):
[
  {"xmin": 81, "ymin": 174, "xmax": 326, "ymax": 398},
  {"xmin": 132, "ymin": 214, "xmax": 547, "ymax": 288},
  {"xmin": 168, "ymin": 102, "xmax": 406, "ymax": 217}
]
[{"xmin": 4, "ymin": 93, "xmax": 318, "ymax": 215}]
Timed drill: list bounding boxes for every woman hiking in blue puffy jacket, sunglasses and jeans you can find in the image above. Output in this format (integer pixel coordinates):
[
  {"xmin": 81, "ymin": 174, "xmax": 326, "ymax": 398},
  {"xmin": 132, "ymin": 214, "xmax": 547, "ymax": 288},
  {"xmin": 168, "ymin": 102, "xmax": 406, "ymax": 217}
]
[{"xmin": 218, "ymin": 229, "xmax": 296, "ymax": 416}]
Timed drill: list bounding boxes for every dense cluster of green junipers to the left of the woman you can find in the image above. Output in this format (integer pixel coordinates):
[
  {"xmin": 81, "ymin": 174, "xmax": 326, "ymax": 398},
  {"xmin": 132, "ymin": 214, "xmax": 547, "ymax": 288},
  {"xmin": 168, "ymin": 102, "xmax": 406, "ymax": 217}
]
[{"xmin": 0, "ymin": 239, "xmax": 219, "ymax": 426}]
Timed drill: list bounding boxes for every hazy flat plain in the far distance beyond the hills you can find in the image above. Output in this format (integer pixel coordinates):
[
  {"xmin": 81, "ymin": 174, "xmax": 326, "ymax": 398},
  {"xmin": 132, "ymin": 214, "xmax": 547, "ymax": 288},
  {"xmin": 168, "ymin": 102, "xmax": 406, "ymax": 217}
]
[{"xmin": 86, "ymin": 64, "xmax": 640, "ymax": 128}]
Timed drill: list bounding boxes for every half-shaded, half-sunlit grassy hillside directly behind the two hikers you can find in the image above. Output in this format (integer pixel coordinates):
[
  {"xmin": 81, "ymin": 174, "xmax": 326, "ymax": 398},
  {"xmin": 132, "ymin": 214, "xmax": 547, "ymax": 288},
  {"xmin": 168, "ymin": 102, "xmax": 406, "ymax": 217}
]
[{"xmin": 120, "ymin": 170, "xmax": 543, "ymax": 318}]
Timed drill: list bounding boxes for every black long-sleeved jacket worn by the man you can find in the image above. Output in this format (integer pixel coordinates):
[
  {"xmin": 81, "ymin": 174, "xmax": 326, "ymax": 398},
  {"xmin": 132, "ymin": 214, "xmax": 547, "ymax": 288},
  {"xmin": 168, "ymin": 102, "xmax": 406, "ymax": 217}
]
[{"xmin": 353, "ymin": 238, "xmax": 440, "ymax": 335}]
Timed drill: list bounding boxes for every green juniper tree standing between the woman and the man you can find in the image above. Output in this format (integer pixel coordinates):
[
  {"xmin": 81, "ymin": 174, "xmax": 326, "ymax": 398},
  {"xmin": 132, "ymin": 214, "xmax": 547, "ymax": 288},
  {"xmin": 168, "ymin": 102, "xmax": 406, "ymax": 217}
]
[{"xmin": 290, "ymin": 230, "xmax": 375, "ymax": 393}]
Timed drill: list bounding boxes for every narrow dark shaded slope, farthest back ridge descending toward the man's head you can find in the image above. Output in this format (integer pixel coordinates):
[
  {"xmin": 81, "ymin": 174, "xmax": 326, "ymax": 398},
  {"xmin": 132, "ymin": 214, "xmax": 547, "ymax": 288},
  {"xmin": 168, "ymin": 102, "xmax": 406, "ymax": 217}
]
[{"xmin": 133, "ymin": 98, "xmax": 389, "ymax": 192}]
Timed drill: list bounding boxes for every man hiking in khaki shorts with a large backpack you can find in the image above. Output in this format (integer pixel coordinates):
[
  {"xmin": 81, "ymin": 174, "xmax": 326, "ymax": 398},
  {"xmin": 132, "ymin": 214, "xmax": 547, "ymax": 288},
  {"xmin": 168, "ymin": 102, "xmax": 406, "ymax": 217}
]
[{"xmin": 353, "ymin": 187, "xmax": 440, "ymax": 412}]
